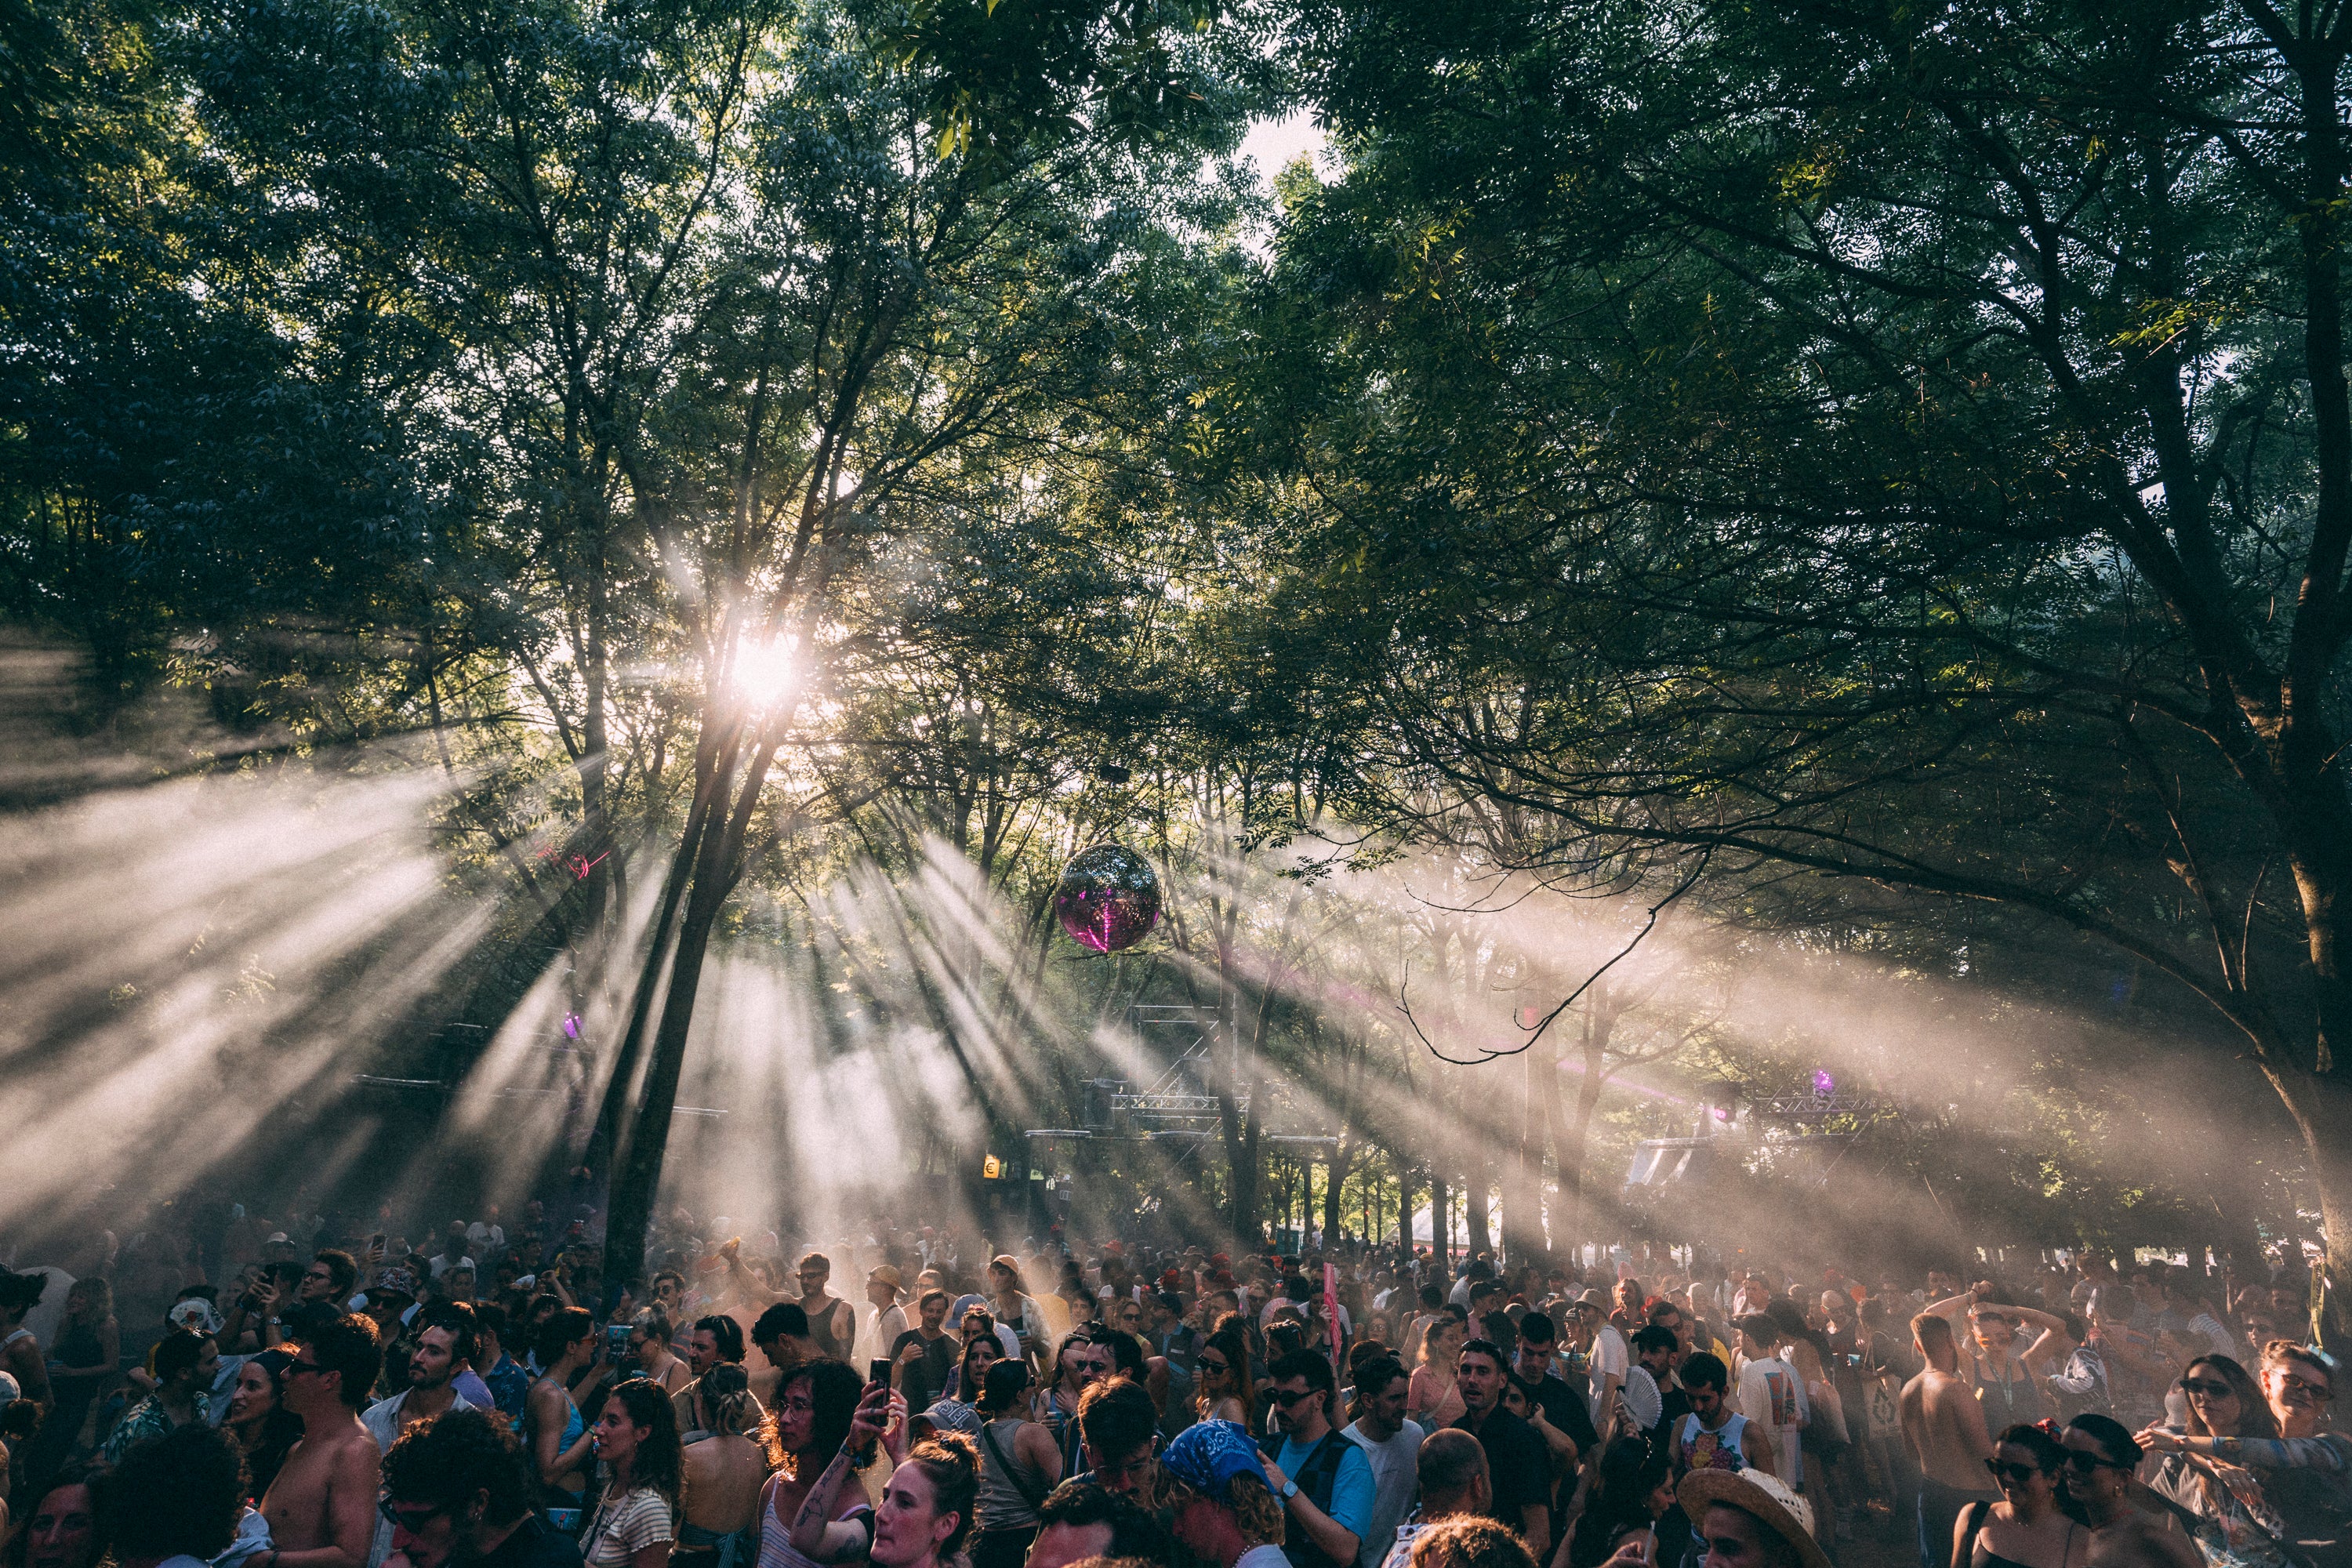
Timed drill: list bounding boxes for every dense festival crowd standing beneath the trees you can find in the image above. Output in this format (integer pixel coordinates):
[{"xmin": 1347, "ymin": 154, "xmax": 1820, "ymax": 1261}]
[{"xmin": 0, "ymin": 1203, "xmax": 2352, "ymax": 1568}]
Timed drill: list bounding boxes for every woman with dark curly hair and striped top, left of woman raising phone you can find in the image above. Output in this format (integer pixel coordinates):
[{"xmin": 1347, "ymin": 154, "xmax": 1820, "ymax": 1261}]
[{"xmin": 753, "ymin": 1359, "xmax": 903, "ymax": 1568}]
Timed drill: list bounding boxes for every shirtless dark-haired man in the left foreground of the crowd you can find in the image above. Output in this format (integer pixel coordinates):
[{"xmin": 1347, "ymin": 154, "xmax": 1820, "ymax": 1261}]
[{"xmin": 252, "ymin": 1316, "xmax": 383, "ymax": 1568}]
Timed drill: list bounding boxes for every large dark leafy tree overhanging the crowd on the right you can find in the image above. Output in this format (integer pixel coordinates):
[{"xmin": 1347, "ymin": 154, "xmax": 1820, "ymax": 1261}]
[{"xmin": 1261, "ymin": 0, "xmax": 2352, "ymax": 1333}]
